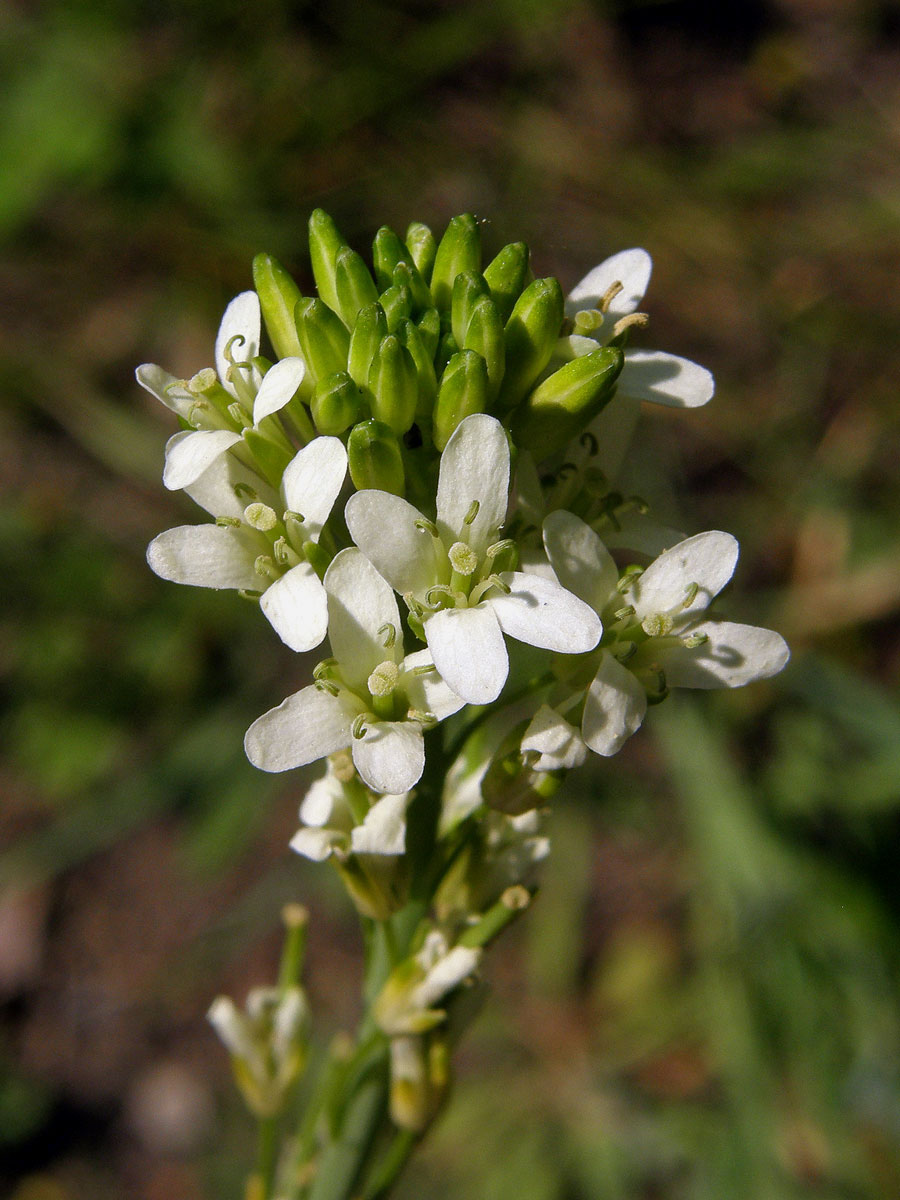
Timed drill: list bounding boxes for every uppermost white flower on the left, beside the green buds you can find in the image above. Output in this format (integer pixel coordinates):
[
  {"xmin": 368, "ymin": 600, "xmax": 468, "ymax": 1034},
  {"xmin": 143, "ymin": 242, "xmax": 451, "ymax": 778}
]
[{"xmin": 136, "ymin": 292, "xmax": 306, "ymax": 490}]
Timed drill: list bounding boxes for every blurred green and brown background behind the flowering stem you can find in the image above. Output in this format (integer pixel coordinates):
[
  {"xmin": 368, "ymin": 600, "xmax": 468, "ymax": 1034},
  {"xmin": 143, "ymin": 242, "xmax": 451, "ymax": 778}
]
[{"xmin": 0, "ymin": 0, "xmax": 900, "ymax": 1200}]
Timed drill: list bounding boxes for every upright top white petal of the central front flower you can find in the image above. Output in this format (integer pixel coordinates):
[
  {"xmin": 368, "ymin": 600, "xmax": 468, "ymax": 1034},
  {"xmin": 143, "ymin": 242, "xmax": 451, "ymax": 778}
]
[{"xmin": 437, "ymin": 413, "xmax": 509, "ymax": 551}]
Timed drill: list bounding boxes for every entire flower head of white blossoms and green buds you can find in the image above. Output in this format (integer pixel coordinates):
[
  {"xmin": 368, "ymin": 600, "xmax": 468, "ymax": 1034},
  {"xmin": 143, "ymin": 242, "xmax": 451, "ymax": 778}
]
[{"xmin": 137, "ymin": 211, "xmax": 788, "ymax": 1128}]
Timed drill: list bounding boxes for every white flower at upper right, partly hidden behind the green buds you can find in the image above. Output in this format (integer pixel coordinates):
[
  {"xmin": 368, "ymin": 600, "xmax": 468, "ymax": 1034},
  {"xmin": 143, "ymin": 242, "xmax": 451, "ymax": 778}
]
[{"xmin": 563, "ymin": 250, "xmax": 714, "ymax": 408}]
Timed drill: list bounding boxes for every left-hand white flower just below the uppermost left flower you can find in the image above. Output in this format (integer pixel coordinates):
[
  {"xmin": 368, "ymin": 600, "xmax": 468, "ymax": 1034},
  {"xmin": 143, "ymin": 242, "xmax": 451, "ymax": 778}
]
[{"xmin": 146, "ymin": 438, "xmax": 347, "ymax": 652}]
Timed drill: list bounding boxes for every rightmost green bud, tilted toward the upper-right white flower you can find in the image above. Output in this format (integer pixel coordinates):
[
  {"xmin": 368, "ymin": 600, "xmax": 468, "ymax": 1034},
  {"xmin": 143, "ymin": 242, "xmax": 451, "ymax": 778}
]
[{"xmin": 511, "ymin": 346, "xmax": 625, "ymax": 461}]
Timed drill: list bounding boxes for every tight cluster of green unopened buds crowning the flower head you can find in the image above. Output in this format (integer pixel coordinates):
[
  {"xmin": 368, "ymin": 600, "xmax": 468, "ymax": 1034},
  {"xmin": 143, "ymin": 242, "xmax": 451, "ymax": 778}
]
[{"xmin": 253, "ymin": 210, "xmax": 623, "ymax": 497}]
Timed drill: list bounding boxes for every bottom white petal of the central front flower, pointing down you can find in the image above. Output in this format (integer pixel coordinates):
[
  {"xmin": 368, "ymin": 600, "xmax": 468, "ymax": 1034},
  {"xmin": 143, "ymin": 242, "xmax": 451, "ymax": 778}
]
[{"xmin": 425, "ymin": 604, "xmax": 509, "ymax": 704}]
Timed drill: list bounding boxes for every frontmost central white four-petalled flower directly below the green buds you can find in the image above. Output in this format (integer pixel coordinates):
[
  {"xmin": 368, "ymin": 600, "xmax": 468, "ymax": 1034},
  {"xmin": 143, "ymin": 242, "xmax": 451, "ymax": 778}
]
[{"xmin": 346, "ymin": 414, "xmax": 601, "ymax": 704}]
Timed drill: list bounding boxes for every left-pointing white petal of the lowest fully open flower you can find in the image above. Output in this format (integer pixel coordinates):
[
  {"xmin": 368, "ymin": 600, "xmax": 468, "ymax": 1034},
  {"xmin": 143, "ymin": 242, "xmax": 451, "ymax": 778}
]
[{"xmin": 244, "ymin": 686, "xmax": 353, "ymax": 770}]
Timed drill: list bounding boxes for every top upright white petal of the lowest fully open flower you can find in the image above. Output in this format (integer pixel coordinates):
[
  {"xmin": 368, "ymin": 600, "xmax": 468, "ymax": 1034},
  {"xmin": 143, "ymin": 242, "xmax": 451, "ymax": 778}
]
[{"xmin": 324, "ymin": 546, "xmax": 403, "ymax": 691}]
